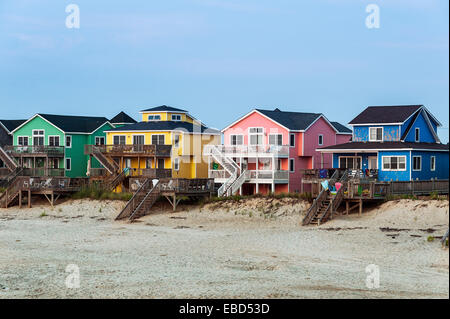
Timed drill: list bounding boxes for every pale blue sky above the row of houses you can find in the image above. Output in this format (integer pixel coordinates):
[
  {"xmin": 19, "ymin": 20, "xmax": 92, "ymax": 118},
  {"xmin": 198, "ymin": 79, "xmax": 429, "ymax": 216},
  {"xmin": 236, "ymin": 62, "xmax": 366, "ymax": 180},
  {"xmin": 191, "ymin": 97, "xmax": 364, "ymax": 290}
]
[{"xmin": 0, "ymin": 0, "xmax": 449, "ymax": 142}]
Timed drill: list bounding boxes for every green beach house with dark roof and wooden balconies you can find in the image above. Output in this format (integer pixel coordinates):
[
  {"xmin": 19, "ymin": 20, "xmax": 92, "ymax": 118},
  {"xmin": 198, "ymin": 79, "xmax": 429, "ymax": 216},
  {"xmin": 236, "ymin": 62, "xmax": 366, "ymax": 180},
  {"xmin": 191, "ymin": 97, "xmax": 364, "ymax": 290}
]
[{"xmin": 6, "ymin": 114, "xmax": 115, "ymax": 178}]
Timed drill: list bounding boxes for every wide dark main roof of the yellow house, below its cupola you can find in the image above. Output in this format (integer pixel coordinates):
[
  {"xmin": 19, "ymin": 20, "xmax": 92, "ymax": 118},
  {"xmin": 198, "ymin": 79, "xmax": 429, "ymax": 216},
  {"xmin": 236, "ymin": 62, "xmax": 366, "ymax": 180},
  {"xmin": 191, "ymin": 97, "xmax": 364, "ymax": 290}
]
[{"xmin": 106, "ymin": 121, "xmax": 220, "ymax": 135}]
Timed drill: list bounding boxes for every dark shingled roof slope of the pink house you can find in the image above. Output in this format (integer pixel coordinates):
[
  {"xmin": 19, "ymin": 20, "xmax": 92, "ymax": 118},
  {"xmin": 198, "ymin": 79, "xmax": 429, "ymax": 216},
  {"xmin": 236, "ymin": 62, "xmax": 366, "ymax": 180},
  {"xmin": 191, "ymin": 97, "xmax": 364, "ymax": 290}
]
[{"xmin": 256, "ymin": 108, "xmax": 322, "ymax": 131}]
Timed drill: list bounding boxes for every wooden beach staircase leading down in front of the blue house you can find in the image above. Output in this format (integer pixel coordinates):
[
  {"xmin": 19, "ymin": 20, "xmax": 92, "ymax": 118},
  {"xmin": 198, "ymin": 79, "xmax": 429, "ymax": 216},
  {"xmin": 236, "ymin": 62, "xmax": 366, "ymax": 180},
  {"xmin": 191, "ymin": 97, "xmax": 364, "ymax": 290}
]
[{"xmin": 302, "ymin": 170, "xmax": 348, "ymax": 226}]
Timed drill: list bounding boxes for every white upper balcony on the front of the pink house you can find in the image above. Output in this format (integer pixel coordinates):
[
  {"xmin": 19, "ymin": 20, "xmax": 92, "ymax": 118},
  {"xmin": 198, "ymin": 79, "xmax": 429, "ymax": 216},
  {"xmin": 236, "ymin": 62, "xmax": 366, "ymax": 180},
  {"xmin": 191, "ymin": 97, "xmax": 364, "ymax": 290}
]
[{"xmin": 209, "ymin": 145, "xmax": 289, "ymax": 158}]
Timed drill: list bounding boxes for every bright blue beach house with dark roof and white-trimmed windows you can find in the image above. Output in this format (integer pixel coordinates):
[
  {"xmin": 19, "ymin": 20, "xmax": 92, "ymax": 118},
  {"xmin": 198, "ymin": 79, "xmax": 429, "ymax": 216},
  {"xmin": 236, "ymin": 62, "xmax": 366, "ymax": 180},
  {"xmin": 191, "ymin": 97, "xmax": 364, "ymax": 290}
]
[{"xmin": 318, "ymin": 105, "xmax": 449, "ymax": 181}]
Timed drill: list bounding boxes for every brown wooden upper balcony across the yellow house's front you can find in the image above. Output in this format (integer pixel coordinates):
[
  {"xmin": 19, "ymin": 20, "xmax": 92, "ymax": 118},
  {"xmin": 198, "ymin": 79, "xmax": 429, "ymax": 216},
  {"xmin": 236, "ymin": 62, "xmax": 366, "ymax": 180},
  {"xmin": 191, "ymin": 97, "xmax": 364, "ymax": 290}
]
[{"xmin": 84, "ymin": 144, "xmax": 172, "ymax": 157}]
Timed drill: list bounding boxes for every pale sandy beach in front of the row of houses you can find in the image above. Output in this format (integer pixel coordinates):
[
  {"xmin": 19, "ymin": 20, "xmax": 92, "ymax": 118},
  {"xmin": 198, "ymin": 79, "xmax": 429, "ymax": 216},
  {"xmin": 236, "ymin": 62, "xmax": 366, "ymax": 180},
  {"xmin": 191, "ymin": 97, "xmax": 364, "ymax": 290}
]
[{"xmin": 0, "ymin": 199, "xmax": 449, "ymax": 298}]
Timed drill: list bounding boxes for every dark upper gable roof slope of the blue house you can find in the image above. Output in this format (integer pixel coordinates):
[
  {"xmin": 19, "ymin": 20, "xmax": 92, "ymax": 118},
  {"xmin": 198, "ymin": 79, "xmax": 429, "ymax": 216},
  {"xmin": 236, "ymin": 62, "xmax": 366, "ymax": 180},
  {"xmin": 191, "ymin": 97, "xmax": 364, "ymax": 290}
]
[{"xmin": 349, "ymin": 105, "xmax": 423, "ymax": 125}]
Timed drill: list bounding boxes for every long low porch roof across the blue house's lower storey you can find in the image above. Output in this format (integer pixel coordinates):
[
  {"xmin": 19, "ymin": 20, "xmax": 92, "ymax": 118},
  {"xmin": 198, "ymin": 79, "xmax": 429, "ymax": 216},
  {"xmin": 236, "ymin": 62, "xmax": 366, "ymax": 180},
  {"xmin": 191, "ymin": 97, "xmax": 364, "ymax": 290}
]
[{"xmin": 319, "ymin": 141, "xmax": 449, "ymax": 151}]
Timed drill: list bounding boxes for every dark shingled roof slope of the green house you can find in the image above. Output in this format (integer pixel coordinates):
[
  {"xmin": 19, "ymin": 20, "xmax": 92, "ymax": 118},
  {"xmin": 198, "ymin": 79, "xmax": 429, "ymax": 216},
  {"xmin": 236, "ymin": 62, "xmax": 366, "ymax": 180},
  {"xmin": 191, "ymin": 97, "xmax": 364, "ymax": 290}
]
[{"xmin": 38, "ymin": 114, "xmax": 108, "ymax": 133}]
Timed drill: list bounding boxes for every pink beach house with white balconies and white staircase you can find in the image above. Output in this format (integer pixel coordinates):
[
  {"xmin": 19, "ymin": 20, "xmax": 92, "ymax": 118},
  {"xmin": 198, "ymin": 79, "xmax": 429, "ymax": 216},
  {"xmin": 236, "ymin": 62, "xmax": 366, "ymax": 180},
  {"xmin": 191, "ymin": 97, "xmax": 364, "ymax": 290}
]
[{"xmin": 205, "ymin": 109, "xmax": 352, "ymax": 195}]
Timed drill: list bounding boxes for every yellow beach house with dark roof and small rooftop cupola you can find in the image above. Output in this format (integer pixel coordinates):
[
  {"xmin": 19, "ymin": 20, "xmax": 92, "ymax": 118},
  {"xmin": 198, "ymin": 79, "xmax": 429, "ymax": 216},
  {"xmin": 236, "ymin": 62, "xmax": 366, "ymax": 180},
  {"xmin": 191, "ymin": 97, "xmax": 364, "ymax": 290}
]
[{"xmin": 99, "ymin": 105, "xmax": 221, "ymax": 178}]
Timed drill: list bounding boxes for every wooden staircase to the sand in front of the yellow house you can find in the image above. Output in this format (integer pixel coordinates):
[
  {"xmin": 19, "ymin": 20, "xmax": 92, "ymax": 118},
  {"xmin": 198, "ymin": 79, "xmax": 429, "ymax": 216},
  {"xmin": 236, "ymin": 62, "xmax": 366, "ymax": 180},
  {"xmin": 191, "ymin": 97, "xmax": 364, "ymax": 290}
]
[{"xmin": 116, "ymin": 179, "xmax": 160, "ymax": 221}]
